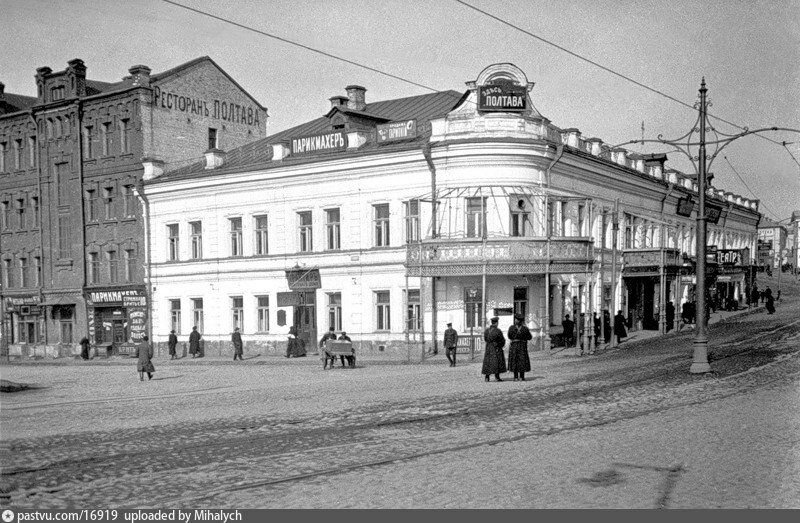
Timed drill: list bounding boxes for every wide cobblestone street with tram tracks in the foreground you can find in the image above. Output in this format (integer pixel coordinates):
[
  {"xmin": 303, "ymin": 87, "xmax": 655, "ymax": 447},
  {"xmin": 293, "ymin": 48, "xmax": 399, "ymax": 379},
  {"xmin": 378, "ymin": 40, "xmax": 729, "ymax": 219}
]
[{"xmin": 0, "ymin": 290, "xmax": 800, "ymax": 508}]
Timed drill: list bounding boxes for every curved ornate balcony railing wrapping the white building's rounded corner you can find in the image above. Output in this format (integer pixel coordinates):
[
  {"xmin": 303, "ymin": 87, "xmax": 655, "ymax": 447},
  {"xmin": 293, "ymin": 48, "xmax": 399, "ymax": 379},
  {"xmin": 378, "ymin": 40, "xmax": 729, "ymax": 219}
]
[{"xmin": 405, "ymin": 237, "xmax": 594, "ymax": 276}]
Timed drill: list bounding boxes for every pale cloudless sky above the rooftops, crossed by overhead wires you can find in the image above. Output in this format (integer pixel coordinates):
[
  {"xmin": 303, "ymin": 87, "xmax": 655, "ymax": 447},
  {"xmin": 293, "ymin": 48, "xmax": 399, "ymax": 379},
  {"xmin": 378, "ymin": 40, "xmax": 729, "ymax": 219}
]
[{"xmin": 0, "ymin": 0, "xmax": 800, "ymax": 220}]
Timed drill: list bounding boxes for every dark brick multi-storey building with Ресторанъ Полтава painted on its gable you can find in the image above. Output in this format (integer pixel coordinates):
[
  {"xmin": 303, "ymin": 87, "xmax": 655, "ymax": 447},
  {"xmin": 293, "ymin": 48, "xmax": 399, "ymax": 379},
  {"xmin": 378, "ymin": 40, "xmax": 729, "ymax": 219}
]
[{"xmin": 0, "ymin": 57, "xmax": 268, "ymax": 360}]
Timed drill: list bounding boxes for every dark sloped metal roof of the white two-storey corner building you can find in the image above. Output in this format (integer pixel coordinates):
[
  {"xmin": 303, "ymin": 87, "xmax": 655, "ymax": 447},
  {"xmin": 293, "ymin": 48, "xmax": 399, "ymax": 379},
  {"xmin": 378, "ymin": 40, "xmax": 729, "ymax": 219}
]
[{"xmin": 155, "ymin": 91, "xmax": 462, "ymax": 183}]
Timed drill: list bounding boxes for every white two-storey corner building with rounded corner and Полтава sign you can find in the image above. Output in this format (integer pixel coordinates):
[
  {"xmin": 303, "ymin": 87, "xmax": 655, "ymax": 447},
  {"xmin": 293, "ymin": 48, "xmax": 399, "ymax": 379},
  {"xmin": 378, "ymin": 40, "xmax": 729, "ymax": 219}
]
[{"xmin": 144, "ymin": 64, "xmax": 759, "ymax": 356}]
